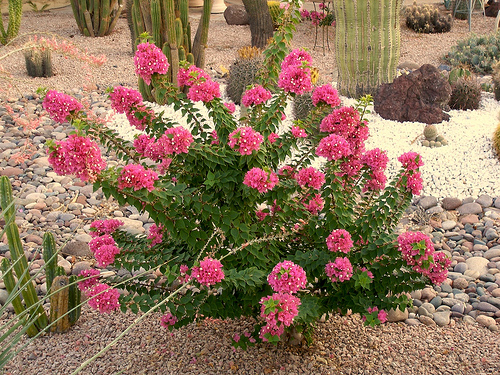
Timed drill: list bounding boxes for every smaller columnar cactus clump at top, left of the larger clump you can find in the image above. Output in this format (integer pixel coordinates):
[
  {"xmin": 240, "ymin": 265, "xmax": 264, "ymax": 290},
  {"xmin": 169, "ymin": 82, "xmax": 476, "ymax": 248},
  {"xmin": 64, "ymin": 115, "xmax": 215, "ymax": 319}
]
[{"xmin": 71, "ymin": 0, "xmax": 123, "ymax": 37}]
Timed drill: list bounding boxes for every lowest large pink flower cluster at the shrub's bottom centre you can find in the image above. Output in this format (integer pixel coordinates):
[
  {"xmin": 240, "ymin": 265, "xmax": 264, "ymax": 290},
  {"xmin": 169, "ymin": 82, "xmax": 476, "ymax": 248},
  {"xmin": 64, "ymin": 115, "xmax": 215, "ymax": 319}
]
[{"xmin": 259, "ymin": 293, "xmax": 300, "ymax": 341}]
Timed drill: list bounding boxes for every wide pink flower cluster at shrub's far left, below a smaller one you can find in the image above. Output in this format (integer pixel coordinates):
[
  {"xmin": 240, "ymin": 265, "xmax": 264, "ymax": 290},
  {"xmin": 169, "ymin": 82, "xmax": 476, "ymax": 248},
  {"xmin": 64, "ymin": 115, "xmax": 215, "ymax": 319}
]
[{"xmin": 49, "ymin": 134, "xmax": 106, "ymax": 182}]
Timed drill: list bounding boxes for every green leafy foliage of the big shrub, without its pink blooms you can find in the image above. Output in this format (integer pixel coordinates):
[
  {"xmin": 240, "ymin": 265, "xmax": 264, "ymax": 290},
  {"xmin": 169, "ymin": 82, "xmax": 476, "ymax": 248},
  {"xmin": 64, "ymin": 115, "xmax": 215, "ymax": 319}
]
[{"xmin": 42, "ymin": 0, "xmax": 446, "ymax": 346}]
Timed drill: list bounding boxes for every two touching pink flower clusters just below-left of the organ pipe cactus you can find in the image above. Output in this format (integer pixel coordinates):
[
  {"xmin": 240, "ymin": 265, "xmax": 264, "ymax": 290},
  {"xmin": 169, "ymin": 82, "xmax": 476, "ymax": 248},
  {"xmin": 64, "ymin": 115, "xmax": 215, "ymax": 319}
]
[{"xmin": 109, "ymin": 86, "xmax": 154, "ymax": 130}]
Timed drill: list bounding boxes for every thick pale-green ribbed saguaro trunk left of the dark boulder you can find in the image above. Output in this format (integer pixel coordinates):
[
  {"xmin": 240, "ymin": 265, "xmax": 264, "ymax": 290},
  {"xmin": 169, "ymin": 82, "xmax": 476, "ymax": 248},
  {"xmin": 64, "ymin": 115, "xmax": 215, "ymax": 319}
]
[{"xmin": 333, "ymin": 0, "xmax": 402, "ymax": 98}]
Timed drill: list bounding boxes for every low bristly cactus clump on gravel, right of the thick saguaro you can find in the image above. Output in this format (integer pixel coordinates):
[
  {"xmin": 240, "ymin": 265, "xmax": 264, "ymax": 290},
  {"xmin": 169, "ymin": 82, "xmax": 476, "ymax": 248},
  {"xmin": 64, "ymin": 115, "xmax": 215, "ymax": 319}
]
[{"xmin": 405, "ymin": 2, "xmax": 452, "ymax": 34}]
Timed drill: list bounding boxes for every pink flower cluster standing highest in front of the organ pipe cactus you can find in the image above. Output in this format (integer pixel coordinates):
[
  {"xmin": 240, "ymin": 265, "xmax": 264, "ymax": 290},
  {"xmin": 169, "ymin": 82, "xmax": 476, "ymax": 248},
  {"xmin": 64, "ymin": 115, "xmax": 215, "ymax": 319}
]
[{"xmin": 134, "ymin": 42, "xmax": 170, "ymax": 85}]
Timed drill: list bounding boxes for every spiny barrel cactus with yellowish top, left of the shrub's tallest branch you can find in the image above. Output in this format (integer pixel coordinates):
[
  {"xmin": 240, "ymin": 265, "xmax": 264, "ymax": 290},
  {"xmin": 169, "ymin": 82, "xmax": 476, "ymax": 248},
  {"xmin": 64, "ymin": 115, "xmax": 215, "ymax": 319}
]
[{"xmin": 226, "ymin": 47, "xmax": 264, "ymax": 104}]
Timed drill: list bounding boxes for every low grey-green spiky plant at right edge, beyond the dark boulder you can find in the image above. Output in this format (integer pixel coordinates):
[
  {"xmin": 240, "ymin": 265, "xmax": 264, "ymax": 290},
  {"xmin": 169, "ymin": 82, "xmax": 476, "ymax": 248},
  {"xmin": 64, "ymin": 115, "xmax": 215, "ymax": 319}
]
[{"xmin": 443, "ymin": 34, "xmax": 500, "ymax": 74}]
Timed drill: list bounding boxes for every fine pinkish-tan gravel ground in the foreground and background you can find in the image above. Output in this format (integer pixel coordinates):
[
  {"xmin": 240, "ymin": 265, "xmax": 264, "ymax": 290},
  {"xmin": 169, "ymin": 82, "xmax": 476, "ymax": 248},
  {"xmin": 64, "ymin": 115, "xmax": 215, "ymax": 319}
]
[{"xmin": 0, "ymin": 8, "xmax": 500, "ymax": 375}]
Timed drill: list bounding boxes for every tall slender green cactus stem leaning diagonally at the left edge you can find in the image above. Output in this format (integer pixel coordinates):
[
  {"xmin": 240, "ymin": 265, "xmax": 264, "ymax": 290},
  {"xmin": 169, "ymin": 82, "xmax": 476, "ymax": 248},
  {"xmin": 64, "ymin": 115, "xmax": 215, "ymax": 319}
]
[{"xmin": 0, "ymin": 176, "xmax": 48, "ymax": 331}]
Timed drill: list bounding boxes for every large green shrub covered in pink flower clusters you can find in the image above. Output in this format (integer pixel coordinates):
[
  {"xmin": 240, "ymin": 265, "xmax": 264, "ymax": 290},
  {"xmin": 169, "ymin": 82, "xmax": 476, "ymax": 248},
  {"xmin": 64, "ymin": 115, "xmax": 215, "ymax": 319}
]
[{"xmin": 44, "ymin": 4, "xmax": 450, "ymax": 345}]
